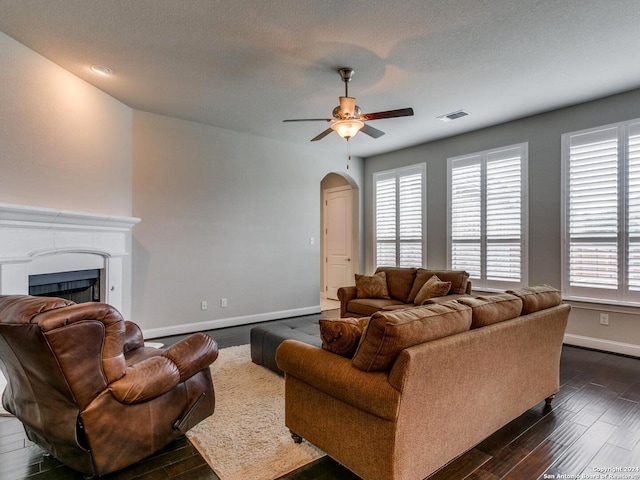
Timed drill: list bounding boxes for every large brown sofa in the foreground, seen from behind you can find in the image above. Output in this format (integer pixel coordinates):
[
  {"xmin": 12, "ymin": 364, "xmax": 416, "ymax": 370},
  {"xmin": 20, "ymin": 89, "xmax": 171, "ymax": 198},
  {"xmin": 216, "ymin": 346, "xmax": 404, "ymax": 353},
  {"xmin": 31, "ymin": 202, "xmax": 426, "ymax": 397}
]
[{"xmin": 276, "ymin": 286, "xmax": 570, "ymax": 480}]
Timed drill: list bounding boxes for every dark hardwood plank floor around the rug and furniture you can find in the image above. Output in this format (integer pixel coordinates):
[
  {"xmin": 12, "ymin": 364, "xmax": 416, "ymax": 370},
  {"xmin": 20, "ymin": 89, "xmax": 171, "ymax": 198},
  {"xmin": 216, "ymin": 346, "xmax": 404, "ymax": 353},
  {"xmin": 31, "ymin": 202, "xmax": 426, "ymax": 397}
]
[{"xmin": 0, "ymin": 312, "xmax": 640, "ymax": 480}]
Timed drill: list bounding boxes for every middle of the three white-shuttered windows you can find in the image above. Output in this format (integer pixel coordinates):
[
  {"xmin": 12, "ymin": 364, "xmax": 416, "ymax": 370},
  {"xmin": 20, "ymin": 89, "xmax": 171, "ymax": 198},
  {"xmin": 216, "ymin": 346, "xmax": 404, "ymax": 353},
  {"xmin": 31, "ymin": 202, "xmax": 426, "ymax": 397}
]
[{"xmin": 447, "ymin": 143, "xmax": 528, "ymax": 290}]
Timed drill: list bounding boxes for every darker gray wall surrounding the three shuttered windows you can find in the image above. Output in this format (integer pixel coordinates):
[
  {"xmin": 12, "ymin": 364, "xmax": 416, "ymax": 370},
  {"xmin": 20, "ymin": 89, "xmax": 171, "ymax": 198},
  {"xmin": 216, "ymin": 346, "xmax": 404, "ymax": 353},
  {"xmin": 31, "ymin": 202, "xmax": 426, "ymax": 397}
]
[{"xmin": 364, "ymin": 90, "xmax": 640, "ymax": 354}]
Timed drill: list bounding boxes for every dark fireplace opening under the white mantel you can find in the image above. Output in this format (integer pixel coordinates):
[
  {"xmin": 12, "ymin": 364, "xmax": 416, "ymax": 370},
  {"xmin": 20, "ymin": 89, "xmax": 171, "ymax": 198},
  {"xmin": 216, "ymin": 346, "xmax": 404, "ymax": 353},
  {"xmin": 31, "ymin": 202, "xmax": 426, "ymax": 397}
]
[{"xmin": 29, "ymin": 269, "xmax": 100, "ymax": 303}]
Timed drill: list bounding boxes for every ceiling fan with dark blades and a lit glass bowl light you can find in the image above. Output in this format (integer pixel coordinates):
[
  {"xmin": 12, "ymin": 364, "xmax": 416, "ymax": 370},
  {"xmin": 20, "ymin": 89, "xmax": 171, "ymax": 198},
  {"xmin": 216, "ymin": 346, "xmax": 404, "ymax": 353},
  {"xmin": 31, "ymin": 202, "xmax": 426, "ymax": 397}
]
[{"xmin": 283, "ymin": 68, "xmax": 413, "ymax": 142}]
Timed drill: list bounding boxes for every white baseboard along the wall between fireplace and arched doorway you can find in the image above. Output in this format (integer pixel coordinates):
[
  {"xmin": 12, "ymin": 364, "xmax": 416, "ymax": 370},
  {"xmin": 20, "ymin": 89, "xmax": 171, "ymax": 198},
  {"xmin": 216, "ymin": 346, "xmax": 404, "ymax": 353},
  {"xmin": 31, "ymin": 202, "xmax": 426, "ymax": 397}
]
[{"xmin": 142, "ymin": 305, "xmax": 321, "ymax": 340}]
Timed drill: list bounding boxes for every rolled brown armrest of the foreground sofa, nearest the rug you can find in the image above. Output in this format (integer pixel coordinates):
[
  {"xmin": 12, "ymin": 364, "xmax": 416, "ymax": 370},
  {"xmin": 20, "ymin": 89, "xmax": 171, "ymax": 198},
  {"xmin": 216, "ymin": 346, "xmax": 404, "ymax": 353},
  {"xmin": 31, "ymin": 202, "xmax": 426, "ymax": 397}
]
[{"xmin": 276, "ymin": 340, "xmax": 400, "ymax": 420}]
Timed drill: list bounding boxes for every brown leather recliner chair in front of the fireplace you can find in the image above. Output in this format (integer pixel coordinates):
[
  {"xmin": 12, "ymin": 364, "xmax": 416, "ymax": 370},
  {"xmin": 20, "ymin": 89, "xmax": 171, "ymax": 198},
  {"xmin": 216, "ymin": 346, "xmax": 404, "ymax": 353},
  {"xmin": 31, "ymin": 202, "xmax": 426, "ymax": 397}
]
[{"xmin": 0, "ymin": 295, "xmax": 218, "ymax": 475}]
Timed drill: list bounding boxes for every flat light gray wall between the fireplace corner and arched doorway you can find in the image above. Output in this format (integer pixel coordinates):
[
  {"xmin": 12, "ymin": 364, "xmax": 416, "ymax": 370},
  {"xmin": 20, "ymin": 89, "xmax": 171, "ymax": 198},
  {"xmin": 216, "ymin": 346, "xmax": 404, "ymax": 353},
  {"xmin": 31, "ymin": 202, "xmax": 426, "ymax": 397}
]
[{"xmin": 133, "ymin": 112, "xmax": 362, "ymax": 336}]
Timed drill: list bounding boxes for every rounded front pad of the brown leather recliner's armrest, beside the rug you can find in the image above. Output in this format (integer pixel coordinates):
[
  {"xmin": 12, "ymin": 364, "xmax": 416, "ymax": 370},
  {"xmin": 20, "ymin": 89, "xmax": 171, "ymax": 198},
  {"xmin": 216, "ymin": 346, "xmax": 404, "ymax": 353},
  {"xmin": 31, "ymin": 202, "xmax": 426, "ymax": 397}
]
[{"xmin": 162, "ymin": 333, "xmax": 218, "ymax": 382}]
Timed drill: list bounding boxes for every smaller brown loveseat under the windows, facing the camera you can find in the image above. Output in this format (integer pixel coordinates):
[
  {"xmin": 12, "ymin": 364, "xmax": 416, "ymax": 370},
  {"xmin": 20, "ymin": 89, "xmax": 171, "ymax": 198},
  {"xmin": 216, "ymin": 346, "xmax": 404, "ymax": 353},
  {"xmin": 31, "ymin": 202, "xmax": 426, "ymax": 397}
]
[{"xmin": 338, "ymin": 267, "xmax": 471, "ymax": 317}]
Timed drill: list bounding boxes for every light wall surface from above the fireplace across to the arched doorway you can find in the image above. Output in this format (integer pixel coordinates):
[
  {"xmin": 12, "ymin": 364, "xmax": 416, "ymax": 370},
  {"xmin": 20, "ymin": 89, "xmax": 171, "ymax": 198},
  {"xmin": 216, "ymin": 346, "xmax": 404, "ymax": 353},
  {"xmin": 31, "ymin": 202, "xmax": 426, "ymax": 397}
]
[{"xmin": 0, "ymin": 32, "xmax": 362, "ymax": 335}]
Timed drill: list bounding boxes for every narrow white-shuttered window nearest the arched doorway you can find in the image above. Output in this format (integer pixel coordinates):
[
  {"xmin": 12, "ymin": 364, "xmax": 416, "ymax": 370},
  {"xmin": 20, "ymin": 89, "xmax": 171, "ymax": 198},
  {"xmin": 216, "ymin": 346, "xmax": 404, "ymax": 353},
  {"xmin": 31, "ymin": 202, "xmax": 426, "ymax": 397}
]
[{"xmin": 373, "ymin": 164, "xmax": 426, "ymax": 267}]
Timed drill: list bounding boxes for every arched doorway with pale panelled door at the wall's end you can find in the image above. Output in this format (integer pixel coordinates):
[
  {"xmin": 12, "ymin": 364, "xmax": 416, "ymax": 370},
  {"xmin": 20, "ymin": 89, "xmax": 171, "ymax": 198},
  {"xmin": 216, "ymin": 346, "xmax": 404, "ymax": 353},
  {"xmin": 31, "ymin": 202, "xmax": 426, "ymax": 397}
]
[{"xmin": 320, "ymin": 172, "xmax": 359, "ymax": 304}]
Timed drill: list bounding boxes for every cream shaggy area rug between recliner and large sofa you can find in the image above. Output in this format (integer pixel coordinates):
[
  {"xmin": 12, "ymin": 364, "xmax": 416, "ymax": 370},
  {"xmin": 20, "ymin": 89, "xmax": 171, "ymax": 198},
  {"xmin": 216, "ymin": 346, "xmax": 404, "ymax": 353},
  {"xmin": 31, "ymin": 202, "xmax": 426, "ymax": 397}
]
[{"xmin": 187, "ymin": 345, "xmax": 324, "ymax": 480}]
